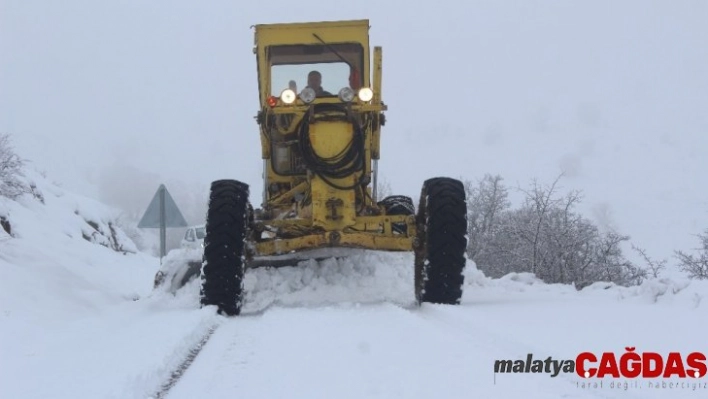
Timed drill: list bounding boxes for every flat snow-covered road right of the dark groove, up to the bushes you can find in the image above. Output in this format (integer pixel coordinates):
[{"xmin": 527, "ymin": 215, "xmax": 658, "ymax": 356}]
[{"xmin": 162, "ymin": 266, "xmax": 708, "ymax": 398}]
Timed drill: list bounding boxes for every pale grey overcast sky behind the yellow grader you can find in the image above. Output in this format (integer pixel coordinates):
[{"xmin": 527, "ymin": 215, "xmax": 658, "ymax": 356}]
[{"xmin": 0, "ymin": 0, "xmax": 708, "ymax": 268}]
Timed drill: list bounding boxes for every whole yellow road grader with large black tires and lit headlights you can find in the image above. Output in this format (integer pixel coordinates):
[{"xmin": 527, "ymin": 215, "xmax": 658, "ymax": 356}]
[{"xmin": 201, "ymin": 20, "xmax": 467, "ymax": 315}]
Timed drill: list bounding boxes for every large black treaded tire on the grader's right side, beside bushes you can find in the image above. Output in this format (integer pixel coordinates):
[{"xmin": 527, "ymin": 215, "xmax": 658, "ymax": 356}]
[{"xmin": 415, "ymin": 177, "xmax": 467, "ymax": 305}]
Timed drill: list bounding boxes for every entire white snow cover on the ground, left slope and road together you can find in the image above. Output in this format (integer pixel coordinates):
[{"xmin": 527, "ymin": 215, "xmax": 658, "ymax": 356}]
[{"xmin": 0, "ymin": 170, "xmax": 708, "ymax": 399}]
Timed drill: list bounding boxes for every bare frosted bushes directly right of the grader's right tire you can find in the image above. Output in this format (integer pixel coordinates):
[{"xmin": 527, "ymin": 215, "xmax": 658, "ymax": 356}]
[{"xmin": 467, "ymin": 175, "xmax": 646, "ymax": 287}]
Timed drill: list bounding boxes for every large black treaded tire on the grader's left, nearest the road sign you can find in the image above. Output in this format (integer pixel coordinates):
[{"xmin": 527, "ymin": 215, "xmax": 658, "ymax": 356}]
[{"xmin": 200, "ymin": 180, "xmax": 250, "ymax": 316}]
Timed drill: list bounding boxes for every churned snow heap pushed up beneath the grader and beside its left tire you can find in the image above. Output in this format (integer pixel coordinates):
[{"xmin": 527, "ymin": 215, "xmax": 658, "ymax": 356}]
[{"xmin": 154, "ymin": 249, "xmax": 415, "ymax": 313}]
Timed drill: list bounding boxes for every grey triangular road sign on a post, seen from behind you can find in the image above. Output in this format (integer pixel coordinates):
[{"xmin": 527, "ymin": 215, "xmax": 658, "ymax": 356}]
[{"xmin": 138, "ymin": 184, "xmax": 188, "ymax": 263}]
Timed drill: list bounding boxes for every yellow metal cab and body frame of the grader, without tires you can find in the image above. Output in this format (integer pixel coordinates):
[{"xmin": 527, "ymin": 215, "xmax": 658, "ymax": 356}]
[{"xmin": 249, "ymin": 20, "xmax": 416, "ymax": 257}]
